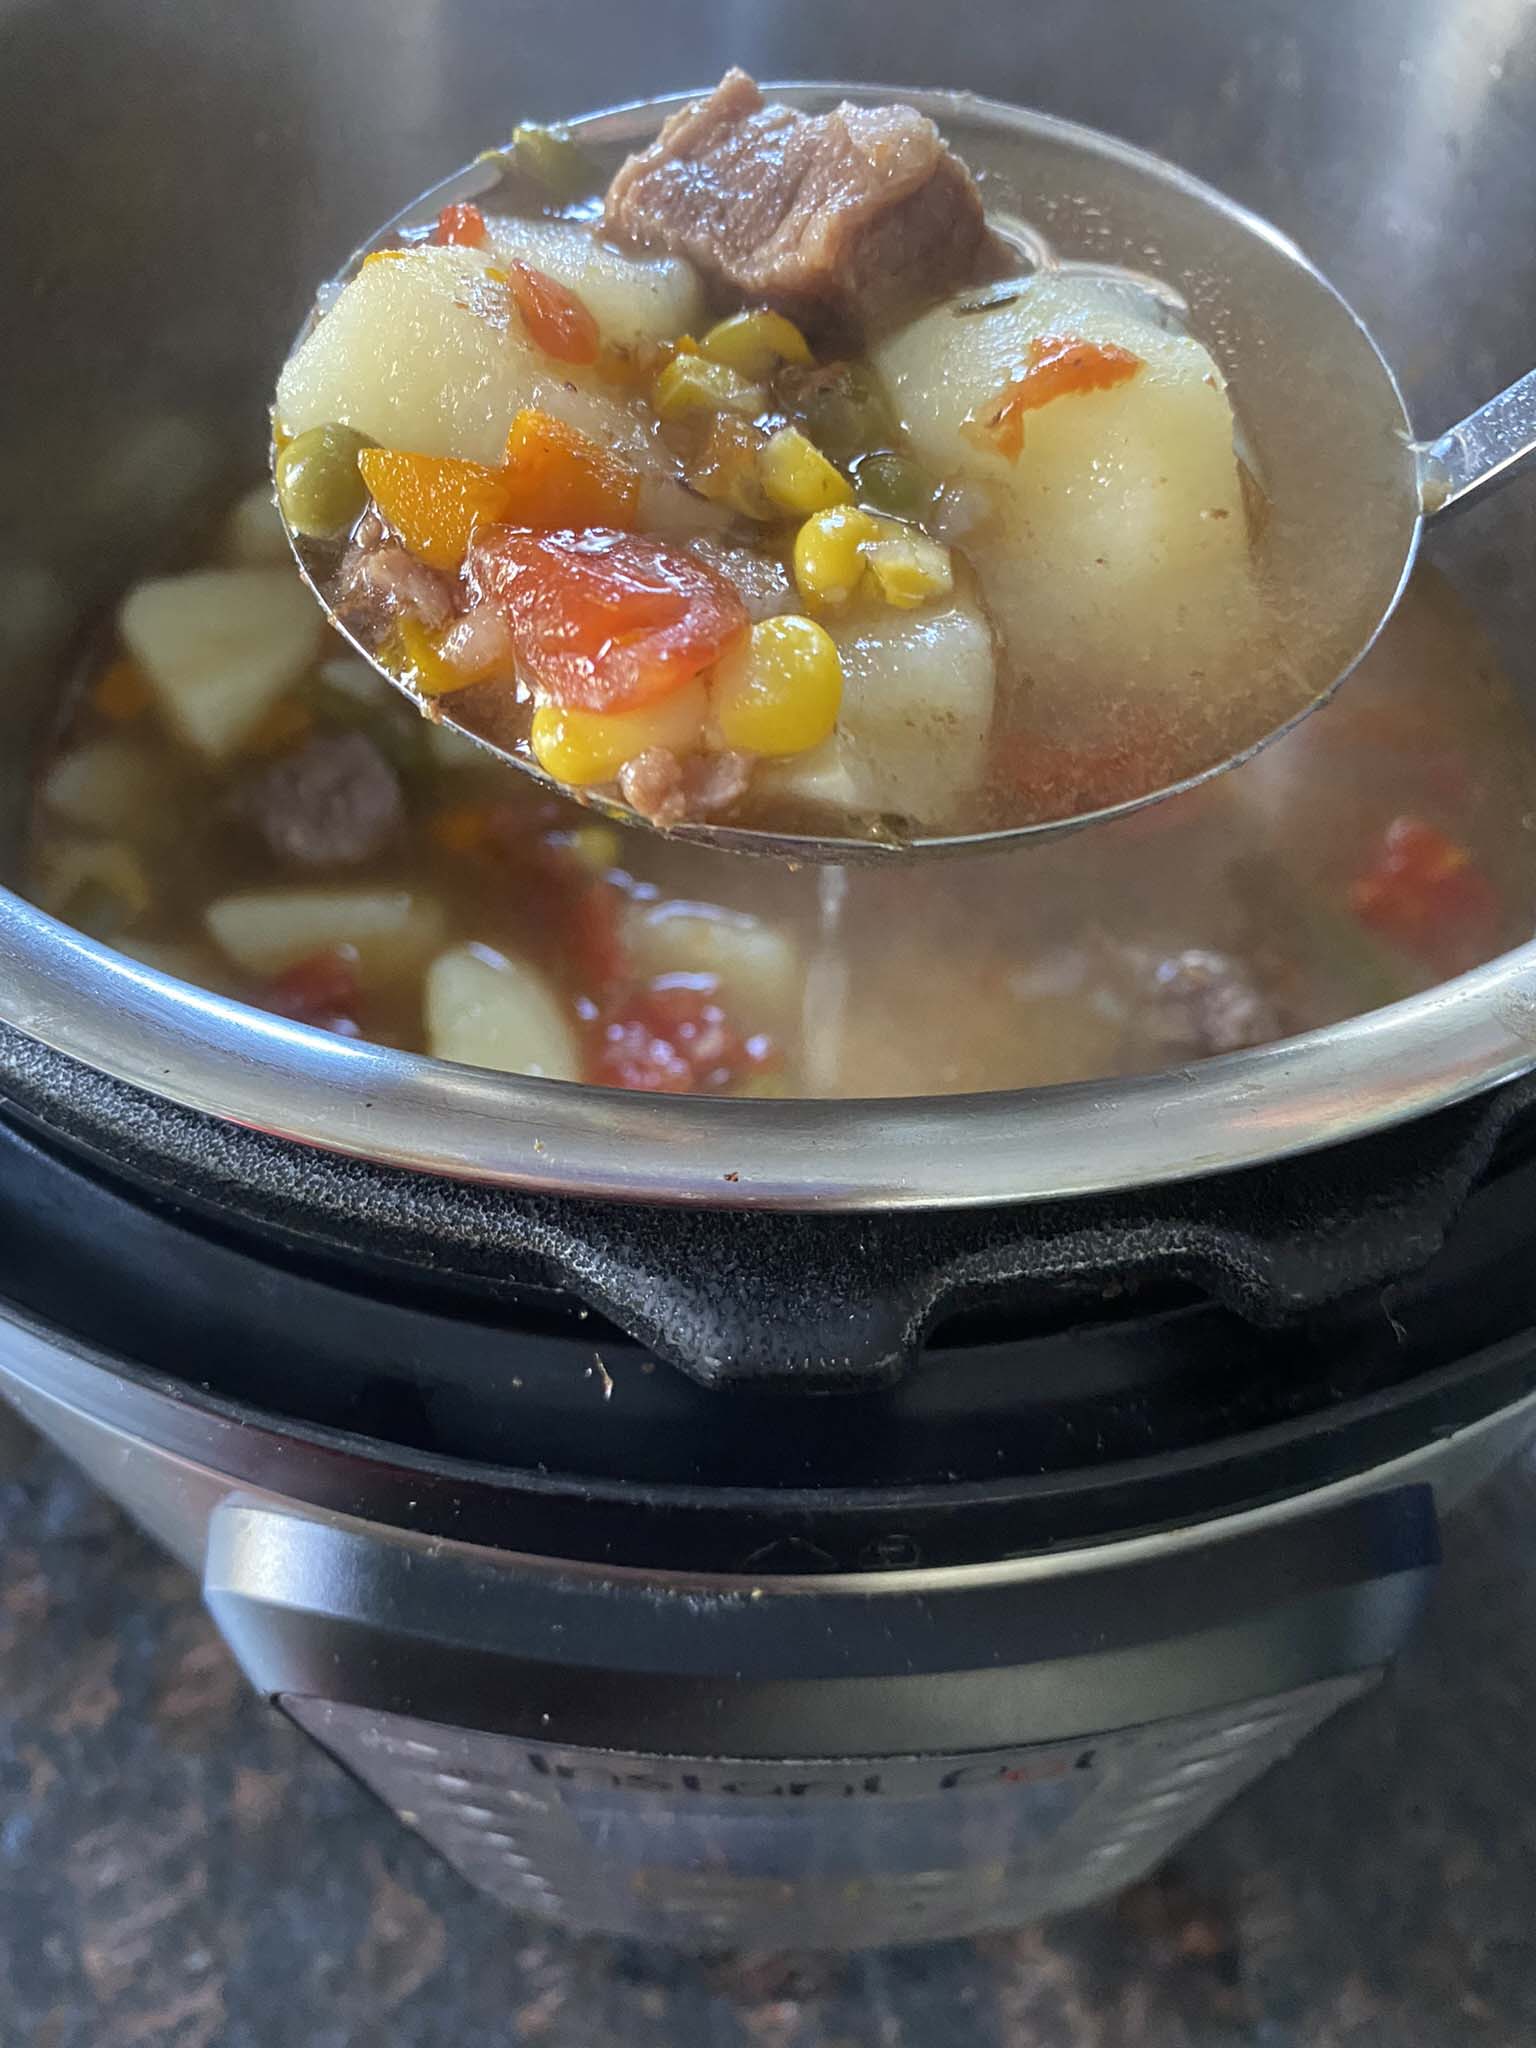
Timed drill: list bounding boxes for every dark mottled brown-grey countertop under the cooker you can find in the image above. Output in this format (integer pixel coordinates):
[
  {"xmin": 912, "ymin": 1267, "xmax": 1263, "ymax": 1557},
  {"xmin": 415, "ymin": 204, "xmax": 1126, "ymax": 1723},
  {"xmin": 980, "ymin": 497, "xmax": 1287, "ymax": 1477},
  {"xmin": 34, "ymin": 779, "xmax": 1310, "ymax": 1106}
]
[{"xmin": 0, "ymin": 1421, "xmax": 1536, "ymax": 2048}]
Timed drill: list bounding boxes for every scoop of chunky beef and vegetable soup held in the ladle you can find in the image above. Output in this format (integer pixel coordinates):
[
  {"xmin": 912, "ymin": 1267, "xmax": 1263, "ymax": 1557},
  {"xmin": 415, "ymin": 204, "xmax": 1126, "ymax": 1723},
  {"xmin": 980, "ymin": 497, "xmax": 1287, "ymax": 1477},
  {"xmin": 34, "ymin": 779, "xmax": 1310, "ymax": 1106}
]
[{"xmin": 268, "ymin": 72, "xmax": 1401, "ymax": 842}]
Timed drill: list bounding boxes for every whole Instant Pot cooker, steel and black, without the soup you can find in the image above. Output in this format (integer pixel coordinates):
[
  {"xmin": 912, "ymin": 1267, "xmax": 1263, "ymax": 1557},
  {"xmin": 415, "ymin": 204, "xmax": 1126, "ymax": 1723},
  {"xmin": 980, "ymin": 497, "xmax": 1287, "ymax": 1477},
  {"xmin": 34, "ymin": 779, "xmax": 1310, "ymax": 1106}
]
[{"xmin": 0, "ymin": 0, "xmax": 1536, "ymax": 1946}]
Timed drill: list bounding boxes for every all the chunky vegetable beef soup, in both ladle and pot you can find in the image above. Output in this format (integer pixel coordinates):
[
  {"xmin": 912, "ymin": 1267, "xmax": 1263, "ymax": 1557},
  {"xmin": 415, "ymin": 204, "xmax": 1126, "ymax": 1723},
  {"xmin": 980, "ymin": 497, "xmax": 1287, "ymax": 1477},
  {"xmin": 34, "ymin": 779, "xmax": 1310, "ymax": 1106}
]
[{"xmin": 15, "ymin": 74, "xmax": 1536, "ymax": 1096}]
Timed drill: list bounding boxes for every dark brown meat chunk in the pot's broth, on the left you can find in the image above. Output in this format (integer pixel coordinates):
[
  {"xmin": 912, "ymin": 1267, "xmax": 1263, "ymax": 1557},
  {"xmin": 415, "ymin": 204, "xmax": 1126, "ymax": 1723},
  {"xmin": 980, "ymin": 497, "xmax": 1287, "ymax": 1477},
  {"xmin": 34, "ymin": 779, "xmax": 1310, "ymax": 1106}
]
[{"xmin": 238, "ymin": 731, "xmax": 406, "ymax": 868}]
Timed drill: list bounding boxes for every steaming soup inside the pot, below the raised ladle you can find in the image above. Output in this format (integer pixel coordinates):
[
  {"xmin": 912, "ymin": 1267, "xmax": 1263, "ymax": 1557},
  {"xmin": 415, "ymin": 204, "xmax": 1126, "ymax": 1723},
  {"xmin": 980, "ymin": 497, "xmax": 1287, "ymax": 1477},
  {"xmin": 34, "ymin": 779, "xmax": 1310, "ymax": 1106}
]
[{"xmin": 25, "ymin": 485, "xmax": 1536, "ymax": 1096}]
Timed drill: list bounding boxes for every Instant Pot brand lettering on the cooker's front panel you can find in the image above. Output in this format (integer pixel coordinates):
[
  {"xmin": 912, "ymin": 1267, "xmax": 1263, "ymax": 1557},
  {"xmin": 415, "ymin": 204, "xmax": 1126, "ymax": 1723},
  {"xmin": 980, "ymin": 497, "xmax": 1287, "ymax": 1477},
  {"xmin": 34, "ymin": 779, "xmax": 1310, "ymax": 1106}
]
[{"xmin": 524, "ymin": 1749, "xmax": 1094, "ymax": 1800}]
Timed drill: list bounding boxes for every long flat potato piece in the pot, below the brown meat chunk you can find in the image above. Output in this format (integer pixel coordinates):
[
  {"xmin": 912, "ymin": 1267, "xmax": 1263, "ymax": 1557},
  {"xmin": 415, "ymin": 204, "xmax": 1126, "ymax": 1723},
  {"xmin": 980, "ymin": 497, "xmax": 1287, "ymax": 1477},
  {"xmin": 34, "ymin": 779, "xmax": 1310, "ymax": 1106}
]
[{"xmin": 203, "ymin": 889, "xmax": 444, "ymax": 981}]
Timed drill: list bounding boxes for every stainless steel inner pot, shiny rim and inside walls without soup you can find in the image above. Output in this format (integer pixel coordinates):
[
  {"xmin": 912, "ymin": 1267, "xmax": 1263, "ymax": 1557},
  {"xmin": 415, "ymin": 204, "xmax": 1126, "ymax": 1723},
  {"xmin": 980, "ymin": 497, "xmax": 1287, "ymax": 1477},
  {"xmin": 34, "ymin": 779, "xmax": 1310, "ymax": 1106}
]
[{"xmin": 0, "ymin": 0, "xmax": 1536, "ymax": 1208}]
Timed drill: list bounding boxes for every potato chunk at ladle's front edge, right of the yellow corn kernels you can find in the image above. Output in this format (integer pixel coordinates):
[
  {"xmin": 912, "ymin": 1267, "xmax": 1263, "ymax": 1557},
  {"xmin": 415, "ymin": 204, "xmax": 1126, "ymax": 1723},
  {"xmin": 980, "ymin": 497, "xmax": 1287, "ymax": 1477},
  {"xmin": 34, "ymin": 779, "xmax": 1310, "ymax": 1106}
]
[{"xmin": 768, "ymin": 598, "xmax": 995, "ymax": 825}]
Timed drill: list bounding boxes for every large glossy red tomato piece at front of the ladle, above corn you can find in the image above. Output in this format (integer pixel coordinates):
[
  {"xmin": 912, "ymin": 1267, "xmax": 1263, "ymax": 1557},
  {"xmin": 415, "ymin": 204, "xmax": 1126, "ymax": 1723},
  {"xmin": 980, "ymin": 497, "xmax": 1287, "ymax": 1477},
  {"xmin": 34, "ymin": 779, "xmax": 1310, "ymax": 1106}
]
[{"xmin": 469, "ymin": 526, "xmax": 748, "ymax": 711}]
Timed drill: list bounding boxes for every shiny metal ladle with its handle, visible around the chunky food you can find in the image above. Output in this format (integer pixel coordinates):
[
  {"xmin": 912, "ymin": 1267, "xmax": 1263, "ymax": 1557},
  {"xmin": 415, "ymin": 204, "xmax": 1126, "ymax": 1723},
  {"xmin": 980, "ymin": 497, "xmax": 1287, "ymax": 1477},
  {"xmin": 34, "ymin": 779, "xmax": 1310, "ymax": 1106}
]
[{"xmin": 276, "ymin": 84, "xmax": 1536, "ymax": 866}]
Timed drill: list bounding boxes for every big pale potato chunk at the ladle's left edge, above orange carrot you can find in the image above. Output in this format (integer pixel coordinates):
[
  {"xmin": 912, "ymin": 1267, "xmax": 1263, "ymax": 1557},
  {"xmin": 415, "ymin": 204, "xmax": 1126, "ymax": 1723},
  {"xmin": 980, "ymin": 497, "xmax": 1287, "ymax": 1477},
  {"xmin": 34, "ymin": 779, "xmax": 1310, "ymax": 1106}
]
[{"xmin": 276, "ymin": 248, "xmax": 647, "ymax": 463}]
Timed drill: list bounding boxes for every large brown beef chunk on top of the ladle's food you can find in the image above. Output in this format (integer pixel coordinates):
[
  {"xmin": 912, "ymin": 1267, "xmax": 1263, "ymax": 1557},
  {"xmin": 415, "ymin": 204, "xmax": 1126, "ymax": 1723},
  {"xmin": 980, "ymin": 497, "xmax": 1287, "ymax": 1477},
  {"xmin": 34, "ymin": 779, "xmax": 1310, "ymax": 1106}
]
[{"xmin": 604, "ymin": 72, "xmax": 999, "ymax": 330}]
